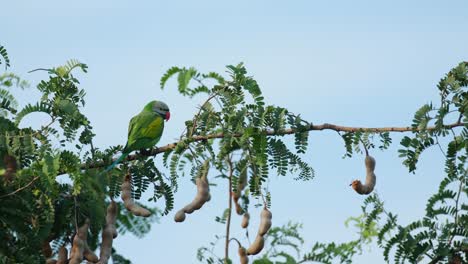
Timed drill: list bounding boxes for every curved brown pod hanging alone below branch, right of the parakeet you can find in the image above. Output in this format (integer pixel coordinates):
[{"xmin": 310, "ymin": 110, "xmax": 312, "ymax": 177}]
[{"xmin": 174, "ymin": 160, "xmax": 211, "ymax": 222}]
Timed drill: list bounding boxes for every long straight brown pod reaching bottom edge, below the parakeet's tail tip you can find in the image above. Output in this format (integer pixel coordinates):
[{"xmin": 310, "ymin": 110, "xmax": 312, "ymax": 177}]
[{"xmin": 98, "ymin": 201, "xmax": 117, "ymax": 264}]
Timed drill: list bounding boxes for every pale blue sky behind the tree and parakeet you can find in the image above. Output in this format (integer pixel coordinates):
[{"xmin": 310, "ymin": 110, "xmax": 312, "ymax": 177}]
[{"xmin": 0, "ymin": 0, "xmax": 468, "ymax": 263}]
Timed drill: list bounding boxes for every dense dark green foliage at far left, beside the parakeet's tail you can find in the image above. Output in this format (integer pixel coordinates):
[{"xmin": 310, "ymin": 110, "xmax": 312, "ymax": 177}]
[{"xmin": 0, "ymin": 56, "xmax": 159, "ymax": 263}]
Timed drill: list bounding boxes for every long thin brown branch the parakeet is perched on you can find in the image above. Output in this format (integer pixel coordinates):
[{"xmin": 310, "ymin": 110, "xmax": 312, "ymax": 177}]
[{"xmin": 81, "ymin": 122, "xmax": 464, "ymax": 169}]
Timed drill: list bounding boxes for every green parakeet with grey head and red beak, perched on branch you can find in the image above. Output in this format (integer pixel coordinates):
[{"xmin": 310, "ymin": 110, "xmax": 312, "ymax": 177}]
[{"xmin": 104, "ymin": 101, "xmax": 171, "ymax": 172}]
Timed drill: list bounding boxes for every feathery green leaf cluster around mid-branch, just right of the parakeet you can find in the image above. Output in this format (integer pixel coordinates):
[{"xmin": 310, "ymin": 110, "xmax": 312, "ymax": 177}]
[{"xmin": 161, "ymin": 64, "xmax": 314, "ymax": 205}]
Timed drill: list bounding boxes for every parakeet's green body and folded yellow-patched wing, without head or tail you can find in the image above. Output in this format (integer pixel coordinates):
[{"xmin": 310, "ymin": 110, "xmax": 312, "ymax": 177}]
[{"xmin": 125, "ymin": 112, "xmax": 164, "ymax": 152}]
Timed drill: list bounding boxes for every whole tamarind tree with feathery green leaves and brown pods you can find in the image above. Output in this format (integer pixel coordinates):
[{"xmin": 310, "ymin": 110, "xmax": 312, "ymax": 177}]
[{"xmin": 0, "ymin": 46, "xmax": 468, "ymax": 263}]
